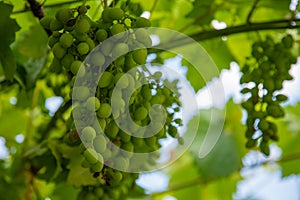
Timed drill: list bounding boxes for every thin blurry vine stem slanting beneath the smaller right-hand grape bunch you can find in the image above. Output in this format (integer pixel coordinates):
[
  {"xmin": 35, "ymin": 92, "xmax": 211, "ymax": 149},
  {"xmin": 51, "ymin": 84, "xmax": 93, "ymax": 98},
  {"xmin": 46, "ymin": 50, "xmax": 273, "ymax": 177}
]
[{"xmin": 151, "ymin": 152, "xmax": 300, "ymax": 197}]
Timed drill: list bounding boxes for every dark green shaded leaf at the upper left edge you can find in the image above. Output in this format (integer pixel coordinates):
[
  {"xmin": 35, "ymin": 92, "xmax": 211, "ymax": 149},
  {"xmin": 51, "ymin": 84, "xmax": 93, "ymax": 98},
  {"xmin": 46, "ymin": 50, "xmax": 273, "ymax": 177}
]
[{"xmin": 0, "ymin": 2, "xmax": 20, "ymax": 80}]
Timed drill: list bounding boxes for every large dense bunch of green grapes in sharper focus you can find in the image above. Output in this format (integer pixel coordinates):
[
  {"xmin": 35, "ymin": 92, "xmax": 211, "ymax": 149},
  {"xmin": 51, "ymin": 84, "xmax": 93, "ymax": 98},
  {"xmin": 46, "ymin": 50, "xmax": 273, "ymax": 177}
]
[{"xmin": 40, "ymin": 6, "xmax": 183, "ymax": 200}]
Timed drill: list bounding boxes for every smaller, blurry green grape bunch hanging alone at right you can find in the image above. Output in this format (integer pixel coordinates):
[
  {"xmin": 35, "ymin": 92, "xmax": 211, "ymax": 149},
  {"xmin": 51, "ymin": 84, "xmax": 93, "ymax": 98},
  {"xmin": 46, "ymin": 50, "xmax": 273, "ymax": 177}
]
[{"xmin": 240, "ymin": 35, "xmax": 297, "ymax": 156}]
